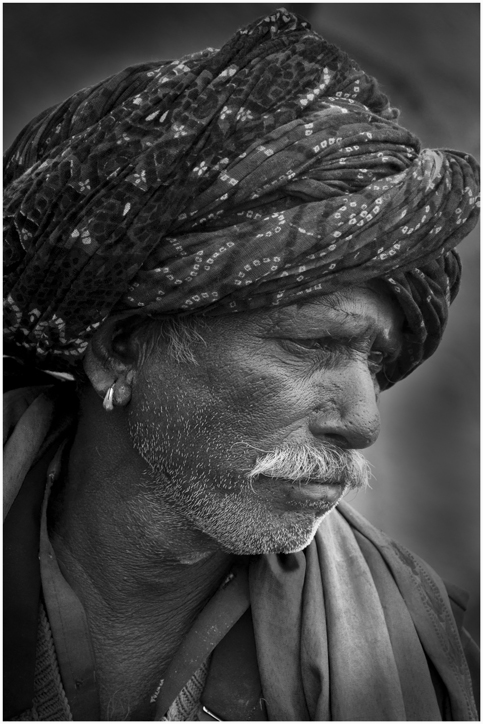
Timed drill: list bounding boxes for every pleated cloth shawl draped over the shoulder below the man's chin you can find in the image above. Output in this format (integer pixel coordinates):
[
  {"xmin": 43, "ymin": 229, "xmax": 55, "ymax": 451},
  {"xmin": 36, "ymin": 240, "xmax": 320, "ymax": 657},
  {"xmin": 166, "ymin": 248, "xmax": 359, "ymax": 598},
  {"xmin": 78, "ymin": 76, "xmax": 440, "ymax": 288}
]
[{"xmin": 250, "ymin": 503, "xmax": 478, "ymax": 721}]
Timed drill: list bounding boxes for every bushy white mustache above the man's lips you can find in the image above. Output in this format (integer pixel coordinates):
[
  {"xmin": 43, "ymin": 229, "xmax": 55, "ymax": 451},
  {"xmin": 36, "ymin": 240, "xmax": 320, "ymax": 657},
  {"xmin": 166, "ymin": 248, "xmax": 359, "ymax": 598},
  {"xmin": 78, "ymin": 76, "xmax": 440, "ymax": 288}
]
[{"xmin": 248, "ymin": 443, "xmax": 372, "ymax": 489}]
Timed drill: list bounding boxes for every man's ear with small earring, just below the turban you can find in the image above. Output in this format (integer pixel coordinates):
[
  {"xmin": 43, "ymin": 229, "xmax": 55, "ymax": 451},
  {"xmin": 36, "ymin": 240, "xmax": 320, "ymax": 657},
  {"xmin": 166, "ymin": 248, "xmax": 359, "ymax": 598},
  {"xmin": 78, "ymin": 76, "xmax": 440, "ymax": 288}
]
[{"xmin": 83, "ymin": 316, "xmax": 139, "ymax": 409}]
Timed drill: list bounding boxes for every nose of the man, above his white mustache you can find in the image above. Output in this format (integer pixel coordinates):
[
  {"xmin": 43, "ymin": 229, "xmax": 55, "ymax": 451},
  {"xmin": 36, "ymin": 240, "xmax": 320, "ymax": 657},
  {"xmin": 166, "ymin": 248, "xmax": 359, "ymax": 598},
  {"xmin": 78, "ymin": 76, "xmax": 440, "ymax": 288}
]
[{"xmin": 309, "ymin": 362, "xmax": 381, "ymax": 449}]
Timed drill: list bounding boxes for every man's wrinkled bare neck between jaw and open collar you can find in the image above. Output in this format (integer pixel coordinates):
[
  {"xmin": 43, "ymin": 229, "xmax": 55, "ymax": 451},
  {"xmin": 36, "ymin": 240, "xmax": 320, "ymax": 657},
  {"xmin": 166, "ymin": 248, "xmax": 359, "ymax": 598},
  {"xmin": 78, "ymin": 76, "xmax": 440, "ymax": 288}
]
[{"xmin": 52, "ymin": 394, "xmax": 232, "ymax": 719}]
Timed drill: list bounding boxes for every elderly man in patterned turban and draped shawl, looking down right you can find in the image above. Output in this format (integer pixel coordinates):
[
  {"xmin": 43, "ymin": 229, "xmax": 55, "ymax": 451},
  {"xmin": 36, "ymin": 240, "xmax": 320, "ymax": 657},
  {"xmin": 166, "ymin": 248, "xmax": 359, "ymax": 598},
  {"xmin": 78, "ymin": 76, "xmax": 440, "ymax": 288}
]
[{"xmin": 4, "ymin": 10, "xmax": 478, "ymax": 721}]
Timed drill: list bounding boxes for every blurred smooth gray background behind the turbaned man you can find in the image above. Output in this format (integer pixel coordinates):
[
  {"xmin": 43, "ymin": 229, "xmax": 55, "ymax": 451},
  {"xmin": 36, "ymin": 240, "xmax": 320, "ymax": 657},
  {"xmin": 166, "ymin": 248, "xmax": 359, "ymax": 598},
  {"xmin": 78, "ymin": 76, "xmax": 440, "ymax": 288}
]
[{"xmin": 3, "ymin": 3, "xmax": 480, "ymax": 639}]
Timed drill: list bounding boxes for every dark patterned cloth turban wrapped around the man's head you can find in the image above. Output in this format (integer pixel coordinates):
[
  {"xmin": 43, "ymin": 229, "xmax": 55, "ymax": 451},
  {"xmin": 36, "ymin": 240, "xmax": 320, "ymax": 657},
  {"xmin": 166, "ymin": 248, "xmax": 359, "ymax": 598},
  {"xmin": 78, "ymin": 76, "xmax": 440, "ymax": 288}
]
[{"xmin": 4, "ymin": 8, "xmax": 478, "ymax": 386}]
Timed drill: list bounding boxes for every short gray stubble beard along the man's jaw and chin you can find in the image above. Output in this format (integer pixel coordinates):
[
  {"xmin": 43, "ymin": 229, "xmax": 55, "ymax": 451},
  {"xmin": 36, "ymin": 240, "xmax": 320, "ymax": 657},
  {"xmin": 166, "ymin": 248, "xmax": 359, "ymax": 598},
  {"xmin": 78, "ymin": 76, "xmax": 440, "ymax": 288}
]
[{"xmin": 130, "ymin": 412, "xmax": 370, "ymax": 555}]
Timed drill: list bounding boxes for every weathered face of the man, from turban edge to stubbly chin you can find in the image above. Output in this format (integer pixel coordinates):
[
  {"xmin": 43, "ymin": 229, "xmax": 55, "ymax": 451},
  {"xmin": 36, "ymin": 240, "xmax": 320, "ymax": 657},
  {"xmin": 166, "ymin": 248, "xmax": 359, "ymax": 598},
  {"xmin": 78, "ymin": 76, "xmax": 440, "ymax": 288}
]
[{"xmin": 129, "ymin": 287, "xmax": 401, "ymax": 554}]
